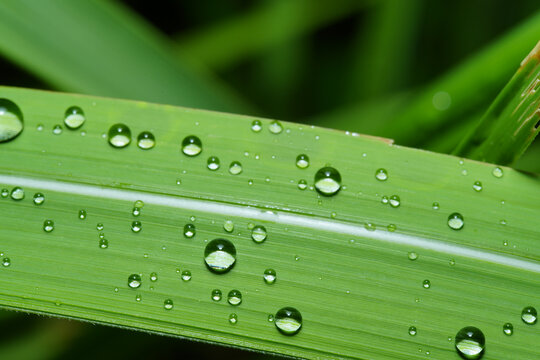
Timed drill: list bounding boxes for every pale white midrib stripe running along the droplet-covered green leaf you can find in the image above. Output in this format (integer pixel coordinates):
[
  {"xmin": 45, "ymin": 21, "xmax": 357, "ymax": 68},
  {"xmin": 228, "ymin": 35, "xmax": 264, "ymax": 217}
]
[{"xmin": 0, "ymin": 174, "xmax": 540, "ymax": 273}]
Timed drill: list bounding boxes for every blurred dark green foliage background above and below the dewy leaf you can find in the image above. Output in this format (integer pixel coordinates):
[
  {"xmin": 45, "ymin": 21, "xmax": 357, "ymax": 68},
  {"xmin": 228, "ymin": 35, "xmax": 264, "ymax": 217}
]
[{"xmin": 0, "ymin": 0, "xmax": 540, "ymax": 359}]
